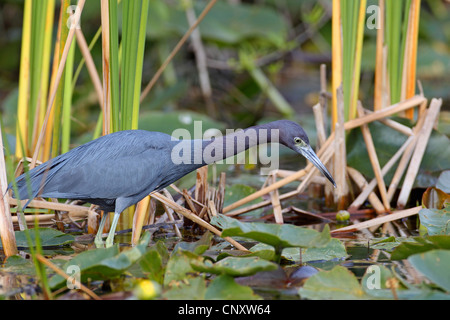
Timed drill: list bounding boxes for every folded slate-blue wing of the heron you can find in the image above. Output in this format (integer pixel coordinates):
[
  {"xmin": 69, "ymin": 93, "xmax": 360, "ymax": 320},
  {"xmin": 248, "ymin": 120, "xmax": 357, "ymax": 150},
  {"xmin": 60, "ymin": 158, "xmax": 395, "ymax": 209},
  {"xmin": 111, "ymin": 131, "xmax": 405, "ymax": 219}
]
[{"xmin": 14, "ymin": 130, "xmax": 176, "ymax": 199}]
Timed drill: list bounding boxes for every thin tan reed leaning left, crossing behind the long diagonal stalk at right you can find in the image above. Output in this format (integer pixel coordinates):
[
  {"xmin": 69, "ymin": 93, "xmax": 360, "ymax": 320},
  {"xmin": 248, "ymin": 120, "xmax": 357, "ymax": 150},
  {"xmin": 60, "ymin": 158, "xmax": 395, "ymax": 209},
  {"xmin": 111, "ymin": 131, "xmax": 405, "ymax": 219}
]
[{"xmin": 357, "ymin": 102, "xmax": 390, "ymax": 211}]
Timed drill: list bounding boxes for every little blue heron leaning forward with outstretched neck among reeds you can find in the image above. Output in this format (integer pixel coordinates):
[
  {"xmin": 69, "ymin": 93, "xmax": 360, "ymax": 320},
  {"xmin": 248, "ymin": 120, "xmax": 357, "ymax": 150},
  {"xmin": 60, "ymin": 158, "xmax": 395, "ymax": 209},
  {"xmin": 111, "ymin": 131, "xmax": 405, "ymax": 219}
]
[{"xmin": 9, "ymin": 120, "xmax": 336, "ymax": 246}]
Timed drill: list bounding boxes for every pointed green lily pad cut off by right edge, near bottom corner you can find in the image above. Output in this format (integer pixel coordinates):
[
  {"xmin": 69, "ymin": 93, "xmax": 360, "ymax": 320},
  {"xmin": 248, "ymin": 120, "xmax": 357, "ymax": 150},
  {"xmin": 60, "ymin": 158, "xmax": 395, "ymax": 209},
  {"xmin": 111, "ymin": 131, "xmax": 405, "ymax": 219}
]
[{"xmin": 408, "ymin": 250, "xmax": 450, "ymax": 292}]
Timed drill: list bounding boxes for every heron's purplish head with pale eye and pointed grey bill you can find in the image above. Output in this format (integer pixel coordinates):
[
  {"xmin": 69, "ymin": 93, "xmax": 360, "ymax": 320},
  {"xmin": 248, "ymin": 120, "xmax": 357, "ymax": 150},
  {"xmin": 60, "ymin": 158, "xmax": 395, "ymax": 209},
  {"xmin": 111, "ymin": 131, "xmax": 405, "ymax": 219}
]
[{"xmin": 276, "ymin": 120, "xmax": 336, "ymax": 187}]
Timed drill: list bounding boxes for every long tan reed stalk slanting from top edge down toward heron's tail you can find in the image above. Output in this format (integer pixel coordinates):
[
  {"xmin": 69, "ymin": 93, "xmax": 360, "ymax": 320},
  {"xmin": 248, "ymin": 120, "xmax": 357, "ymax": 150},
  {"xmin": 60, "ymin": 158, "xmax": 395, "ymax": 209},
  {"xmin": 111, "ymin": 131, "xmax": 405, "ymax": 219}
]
[{"xmin": 30, "ymin": 0, "xmax": 86, "ymax": 169}]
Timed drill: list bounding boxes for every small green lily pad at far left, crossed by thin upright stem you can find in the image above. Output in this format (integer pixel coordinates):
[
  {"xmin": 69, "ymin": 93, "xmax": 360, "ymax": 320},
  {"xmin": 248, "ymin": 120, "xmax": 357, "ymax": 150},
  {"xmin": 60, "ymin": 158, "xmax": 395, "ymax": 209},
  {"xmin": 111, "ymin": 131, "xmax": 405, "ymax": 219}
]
[{"xmin": 10, "ymin": 228, "xmax": 75, "ymax": 248}]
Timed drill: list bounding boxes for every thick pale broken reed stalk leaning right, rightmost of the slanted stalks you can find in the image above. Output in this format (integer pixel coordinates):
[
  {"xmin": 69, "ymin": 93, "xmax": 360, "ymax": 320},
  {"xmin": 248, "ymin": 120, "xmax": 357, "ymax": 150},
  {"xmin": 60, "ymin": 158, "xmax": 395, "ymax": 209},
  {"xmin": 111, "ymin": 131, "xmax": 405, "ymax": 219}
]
[{"xmin": 397, "ymin": 99, "xmax": 442, "ymax": 209}]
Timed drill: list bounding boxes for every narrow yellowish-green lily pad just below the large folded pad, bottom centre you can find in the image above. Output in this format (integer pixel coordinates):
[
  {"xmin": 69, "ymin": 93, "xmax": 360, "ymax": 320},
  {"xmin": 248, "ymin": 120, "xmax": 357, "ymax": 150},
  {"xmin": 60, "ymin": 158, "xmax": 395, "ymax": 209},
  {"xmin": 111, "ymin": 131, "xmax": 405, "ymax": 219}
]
[{"xmin": 191, "ymin": 257, "xmax": 278, "ymax": 277}]
